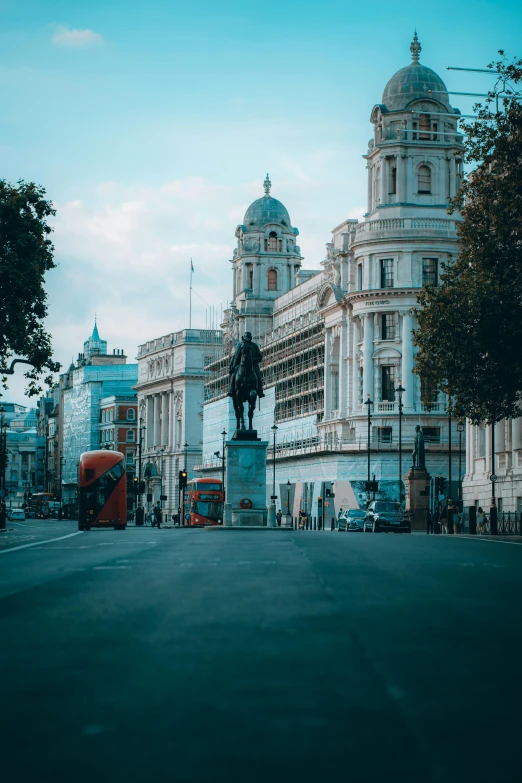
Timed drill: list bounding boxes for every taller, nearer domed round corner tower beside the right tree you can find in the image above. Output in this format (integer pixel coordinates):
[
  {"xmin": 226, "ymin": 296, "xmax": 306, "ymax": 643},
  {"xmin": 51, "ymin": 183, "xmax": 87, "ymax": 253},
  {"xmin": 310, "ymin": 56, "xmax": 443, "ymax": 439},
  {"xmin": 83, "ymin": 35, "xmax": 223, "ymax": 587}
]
[{"xmin": 347, "ymin": 33, "xmax": 464, "ymax": 428}]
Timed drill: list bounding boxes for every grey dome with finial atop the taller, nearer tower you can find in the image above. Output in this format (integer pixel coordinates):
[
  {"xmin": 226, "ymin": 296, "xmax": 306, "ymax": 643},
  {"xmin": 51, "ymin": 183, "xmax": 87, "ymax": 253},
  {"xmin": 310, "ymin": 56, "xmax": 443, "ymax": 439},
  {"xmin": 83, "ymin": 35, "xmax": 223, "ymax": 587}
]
[{"xmin": 382, "ymin": 33, "xmax": 452, "ymax": 111}]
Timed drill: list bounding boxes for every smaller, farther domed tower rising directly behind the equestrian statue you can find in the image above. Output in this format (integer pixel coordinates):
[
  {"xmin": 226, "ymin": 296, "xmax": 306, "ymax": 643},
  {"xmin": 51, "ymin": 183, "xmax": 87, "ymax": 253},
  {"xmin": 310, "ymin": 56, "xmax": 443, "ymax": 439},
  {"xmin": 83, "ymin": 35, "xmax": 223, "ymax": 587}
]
[{"xmin": 231, "ymin": 174, "xmax": 302, "ymax": 338}]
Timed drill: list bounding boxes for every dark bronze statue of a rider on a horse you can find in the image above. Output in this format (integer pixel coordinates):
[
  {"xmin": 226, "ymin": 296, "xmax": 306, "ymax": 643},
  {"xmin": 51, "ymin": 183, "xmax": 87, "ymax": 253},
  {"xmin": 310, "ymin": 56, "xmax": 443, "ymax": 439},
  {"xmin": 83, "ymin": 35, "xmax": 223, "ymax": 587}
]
[{"xmin": 228, "ymin": 332, "xmax": 265, "ymax": 430}]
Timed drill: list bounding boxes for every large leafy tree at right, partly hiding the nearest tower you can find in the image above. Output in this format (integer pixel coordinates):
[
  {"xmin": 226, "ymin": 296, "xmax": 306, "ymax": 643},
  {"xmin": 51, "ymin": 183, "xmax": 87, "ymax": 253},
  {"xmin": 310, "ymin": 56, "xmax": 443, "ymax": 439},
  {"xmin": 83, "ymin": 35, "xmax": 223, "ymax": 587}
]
[{"xmin": 414, "ymin": 51, "xmax": 522, "ymax": 424}]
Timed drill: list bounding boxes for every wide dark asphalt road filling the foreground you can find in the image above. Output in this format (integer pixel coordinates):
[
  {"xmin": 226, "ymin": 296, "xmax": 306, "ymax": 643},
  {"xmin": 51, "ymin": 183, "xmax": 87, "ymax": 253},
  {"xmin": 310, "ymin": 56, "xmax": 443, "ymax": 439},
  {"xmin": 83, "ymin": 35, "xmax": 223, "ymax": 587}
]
[{"xmin": 0, "ymin": 520, "xmax": 522, "ymax": 783}]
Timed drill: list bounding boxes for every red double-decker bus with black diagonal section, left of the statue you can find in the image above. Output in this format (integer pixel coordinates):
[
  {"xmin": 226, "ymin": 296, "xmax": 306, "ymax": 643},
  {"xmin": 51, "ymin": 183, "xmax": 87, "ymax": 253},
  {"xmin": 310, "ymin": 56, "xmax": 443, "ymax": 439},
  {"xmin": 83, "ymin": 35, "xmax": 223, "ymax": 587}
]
[{"xmin": 78, "ymin": 449, "xmax": 127, "ymax": 530}]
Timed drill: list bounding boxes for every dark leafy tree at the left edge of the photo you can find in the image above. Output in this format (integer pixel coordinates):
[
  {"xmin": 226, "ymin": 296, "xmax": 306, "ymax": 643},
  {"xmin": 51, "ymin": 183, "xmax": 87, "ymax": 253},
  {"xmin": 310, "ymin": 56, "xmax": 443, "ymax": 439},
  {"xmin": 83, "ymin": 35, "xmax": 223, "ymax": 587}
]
[{"xmin": 0, "ymin": 180, "xmax": 60, "ymax": 396}]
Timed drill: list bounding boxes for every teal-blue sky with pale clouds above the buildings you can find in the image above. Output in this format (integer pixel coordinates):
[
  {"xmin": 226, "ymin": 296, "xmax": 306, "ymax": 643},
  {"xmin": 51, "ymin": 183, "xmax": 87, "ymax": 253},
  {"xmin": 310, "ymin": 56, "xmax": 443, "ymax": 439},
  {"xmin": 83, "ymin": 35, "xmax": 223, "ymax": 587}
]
[{"xmin": 0, "ymin": 0, "xmax": 522, "ymax": 401}]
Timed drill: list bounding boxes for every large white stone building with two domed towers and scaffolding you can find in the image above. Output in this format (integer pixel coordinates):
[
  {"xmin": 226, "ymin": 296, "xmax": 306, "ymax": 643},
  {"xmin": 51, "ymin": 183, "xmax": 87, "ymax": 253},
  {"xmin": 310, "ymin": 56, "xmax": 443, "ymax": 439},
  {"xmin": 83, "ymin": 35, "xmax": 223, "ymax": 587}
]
[{"xmin": 201, "ymin": 35, "xmax": 463, "ymax": 513}]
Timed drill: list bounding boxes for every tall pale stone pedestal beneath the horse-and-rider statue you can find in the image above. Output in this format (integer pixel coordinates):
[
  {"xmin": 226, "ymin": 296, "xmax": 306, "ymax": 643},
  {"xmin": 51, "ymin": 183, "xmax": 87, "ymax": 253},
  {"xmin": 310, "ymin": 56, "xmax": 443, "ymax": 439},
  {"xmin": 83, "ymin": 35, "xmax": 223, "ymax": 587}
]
[{"xmin": 223, "ymin": 430, "xmax": 268, "ymax": 527}]
